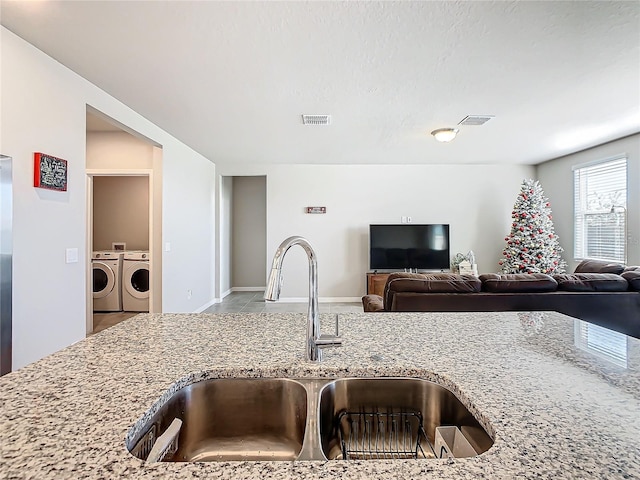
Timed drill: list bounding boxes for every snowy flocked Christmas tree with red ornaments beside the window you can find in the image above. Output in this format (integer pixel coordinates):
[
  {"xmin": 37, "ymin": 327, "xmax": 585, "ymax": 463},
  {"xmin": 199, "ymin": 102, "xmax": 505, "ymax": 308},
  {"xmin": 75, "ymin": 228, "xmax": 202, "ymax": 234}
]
[{"xmin": 498, "ymin": 179, "xmax": 566, "ymax": 274}]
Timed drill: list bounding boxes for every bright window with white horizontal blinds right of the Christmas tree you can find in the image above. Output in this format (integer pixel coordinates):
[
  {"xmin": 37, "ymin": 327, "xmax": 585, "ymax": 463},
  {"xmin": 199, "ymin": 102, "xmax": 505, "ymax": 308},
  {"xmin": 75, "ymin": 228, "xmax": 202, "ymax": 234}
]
[{"xmin": 573, "ymin": 156, "xmax": 627, "ymax": 264}]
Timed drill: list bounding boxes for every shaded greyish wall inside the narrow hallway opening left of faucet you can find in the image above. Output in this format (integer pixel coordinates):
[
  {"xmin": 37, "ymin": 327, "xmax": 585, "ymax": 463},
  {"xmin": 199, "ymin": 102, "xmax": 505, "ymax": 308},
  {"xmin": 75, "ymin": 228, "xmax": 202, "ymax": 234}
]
[{"xmin": 231, "ymin": 176, "xmax": 267, "ymax": 290}]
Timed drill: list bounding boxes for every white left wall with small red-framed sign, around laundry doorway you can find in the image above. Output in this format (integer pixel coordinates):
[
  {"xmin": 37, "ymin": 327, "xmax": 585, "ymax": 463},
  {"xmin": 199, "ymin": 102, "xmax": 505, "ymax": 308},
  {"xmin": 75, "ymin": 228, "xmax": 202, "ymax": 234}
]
[{"xmin": 0, "ymin": 27, "xmax": 215, "ymax": 369}]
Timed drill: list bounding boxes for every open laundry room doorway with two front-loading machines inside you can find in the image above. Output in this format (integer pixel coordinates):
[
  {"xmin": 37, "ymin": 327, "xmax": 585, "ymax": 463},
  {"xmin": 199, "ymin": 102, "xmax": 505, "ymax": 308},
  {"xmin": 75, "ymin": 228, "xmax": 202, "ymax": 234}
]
[{"xmin": 86, "ymin": 107, "xmax": 162, "ymax": 335}]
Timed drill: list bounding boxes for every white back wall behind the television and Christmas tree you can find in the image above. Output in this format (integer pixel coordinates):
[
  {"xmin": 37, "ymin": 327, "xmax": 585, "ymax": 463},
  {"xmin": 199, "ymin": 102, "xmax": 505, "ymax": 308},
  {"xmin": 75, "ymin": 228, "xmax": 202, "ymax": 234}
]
[{"xmin": 217, "ymin": 163, "xmax": 534, "ymax": 299}]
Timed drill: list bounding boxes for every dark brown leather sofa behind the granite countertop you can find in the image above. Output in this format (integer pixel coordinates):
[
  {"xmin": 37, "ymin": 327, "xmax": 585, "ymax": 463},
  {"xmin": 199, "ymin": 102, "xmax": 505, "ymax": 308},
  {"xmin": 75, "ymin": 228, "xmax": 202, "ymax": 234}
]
[{"xmin": 362, "ymin": 260, "xmax": 640, "ymax": 338}]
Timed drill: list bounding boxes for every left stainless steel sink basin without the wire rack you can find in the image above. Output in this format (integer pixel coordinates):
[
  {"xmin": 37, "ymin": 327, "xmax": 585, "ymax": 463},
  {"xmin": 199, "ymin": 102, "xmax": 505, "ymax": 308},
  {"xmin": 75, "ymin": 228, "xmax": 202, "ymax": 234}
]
[{"xmin": 130, "ymin": 378, "xmax": 307, "ymax": 462}]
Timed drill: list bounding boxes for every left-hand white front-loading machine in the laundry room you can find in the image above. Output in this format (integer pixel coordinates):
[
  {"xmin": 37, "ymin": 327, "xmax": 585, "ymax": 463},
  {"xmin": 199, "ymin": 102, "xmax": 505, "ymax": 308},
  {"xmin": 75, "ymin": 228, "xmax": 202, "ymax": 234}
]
[{"xmin": 91, "ymin": 250, "xmax": 123, "ymax": 312}]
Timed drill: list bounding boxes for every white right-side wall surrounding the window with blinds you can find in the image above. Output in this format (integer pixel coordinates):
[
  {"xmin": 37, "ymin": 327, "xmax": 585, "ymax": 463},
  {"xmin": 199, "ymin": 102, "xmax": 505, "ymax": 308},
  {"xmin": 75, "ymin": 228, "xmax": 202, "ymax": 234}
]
[{"xmin": 536, "ymin": 134, "xmax": 640, "ymax": 272}]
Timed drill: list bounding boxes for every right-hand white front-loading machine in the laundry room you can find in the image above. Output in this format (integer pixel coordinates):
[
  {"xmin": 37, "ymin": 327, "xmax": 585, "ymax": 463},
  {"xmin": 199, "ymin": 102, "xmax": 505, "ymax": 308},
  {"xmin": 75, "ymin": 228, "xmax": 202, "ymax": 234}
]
[{"xmin": 122, "ymin": 251, "xmax": 149, "ymax": 312}]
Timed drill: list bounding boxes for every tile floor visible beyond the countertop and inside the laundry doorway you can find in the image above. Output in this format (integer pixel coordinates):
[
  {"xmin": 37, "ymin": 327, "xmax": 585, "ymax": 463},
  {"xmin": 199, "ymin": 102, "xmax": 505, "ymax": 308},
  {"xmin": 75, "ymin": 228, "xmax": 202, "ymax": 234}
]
[{"xmin": 93, "ymin": 292, "xmax": 362, "ymax": 333}]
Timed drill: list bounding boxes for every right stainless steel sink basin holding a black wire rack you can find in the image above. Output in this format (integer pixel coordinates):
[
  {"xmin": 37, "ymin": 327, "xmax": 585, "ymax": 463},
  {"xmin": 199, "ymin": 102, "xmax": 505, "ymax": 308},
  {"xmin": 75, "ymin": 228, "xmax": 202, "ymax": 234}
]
[{"xmin": 318, "ymin": 378, "xmax": 493, "ymax": 460}]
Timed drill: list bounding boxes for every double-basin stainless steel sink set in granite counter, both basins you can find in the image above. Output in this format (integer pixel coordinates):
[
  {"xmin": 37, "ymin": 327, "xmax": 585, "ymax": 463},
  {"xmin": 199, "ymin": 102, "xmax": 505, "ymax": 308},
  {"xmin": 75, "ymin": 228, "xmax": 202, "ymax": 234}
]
[{"xmin": 127, "ymin": 377, "xmax": 493, "ymax": 462}]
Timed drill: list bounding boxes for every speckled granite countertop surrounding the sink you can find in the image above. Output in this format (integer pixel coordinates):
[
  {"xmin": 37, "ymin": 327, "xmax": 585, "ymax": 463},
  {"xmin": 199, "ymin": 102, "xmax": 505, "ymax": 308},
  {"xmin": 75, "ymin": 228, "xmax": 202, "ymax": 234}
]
[{"xmin": 0, "ymin": 312, "xmax": 640, "ymax": 480}]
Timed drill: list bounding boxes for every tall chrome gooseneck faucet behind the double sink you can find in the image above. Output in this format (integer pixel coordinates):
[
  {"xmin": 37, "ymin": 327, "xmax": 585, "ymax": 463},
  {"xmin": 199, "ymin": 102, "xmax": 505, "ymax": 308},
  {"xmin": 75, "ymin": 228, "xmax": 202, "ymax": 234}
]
[{"xmin": 264, "ymin": 236, "xmax": 342, "ymax": 362}]
